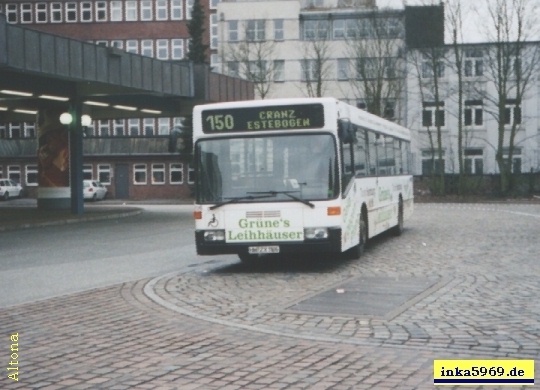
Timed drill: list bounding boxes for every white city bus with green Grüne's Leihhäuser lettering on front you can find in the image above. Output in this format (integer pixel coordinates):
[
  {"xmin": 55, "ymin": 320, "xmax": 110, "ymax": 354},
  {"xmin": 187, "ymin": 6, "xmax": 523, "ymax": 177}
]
[{"xmin": 193, "ymin": 98, "xmax": 413, "ymax": 262}]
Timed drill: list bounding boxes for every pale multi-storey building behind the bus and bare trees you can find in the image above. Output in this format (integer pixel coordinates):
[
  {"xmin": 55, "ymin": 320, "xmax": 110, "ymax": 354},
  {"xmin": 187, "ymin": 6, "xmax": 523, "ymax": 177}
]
[{"xmin": 212, "ymin": 0, "xmax": 540, "ymax": 174}]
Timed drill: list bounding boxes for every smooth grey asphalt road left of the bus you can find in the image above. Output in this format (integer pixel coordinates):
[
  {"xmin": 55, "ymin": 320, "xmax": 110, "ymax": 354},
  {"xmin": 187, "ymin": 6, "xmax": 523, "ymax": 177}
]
[{"xmin": 0, "ymin": 204, "xmax": 196, "ymax": 307}]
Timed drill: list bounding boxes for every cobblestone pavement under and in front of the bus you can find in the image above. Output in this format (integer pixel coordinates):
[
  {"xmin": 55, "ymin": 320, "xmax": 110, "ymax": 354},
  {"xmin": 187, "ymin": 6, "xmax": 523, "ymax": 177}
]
[{"xmin": 0, "ymin": 204, "xmax": 540, "ymax": 390}]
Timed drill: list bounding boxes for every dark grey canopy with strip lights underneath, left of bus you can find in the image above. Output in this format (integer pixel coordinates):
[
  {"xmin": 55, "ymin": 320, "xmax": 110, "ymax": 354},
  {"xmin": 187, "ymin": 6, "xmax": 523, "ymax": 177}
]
[{"xmin": 0, "ymin": 14, "xmax": 221, "ymax": 122}]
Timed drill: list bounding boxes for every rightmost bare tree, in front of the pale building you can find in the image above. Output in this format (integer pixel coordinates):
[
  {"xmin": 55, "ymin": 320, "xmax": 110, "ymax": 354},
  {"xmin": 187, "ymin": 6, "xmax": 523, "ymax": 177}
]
[{"xmin": 476, "ymin": 0, "xmax": 540, "ymax": 194}]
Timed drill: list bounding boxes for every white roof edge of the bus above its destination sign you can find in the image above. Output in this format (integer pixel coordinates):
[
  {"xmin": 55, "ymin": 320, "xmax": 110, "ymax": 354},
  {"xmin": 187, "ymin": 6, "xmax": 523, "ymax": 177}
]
[{"xmin": 193, "ymin": 97, "xmax": 411, "ymax": 141}]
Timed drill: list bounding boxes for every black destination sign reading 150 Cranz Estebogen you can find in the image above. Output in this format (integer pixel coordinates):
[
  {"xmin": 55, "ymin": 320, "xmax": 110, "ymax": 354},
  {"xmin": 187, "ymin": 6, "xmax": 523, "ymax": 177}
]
[{"xmin": 202, "ymin": 103, "xmax": 324, "ymax": 133}]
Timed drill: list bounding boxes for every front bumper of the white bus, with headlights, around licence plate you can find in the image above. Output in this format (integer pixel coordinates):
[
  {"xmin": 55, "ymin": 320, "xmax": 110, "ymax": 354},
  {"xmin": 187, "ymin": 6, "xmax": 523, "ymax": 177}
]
[{"xmin": 195, "ymin": 228, "xmax": 341, "ymax": 255}]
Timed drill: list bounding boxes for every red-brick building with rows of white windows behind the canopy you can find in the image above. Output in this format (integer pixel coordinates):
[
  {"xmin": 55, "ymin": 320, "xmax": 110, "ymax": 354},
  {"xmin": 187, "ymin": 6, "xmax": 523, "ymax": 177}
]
[{"xmin": 0, "ymin": 0, "xmax": 226, "ymax": 199}]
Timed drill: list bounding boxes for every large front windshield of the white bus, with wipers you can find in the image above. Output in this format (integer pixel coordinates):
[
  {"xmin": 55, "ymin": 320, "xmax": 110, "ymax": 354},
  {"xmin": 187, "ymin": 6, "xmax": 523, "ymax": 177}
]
[{"xmin": 195, "ymin": 133, "xmax": 339, "ymax": 204}]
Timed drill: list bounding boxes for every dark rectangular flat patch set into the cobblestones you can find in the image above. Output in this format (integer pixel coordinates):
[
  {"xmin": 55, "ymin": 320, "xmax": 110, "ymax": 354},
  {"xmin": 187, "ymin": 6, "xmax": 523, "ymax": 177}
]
[{"xmin": 286, "ymin": 277, "xmax": 448, "ymax": 320}]
